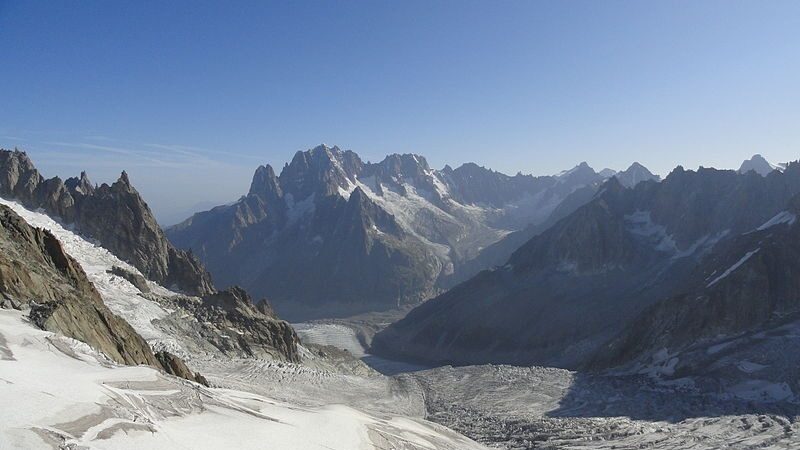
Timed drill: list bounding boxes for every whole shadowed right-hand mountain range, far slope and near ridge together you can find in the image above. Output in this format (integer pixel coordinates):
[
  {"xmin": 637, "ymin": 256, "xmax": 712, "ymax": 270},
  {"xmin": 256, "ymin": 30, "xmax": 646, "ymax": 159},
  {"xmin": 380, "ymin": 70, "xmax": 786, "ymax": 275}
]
[{"xmin": 373, "ymin": 158, "xmax": 800, "ymax": 376}]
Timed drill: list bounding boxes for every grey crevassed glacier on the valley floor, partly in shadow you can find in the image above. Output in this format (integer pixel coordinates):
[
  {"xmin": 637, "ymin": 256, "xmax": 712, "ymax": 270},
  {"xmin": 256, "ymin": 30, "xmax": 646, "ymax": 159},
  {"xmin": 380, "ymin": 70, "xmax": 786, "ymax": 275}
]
[{"xmin": 298, "ymin": 323, "xmax": 800, "ymax": 449}]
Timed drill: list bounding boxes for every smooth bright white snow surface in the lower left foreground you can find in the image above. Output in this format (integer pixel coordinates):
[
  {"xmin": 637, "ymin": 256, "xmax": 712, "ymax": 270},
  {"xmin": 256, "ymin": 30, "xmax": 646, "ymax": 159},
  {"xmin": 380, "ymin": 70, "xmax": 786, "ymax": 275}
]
[{"xmin": 0, "ymin": 310, "xmax": 483, "ymax": 450}]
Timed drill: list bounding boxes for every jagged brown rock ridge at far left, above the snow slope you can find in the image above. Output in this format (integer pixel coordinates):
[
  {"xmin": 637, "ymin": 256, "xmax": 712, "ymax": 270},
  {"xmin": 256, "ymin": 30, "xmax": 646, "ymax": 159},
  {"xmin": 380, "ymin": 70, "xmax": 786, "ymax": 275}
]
[{"xmin": 0, "ymin": 150, "xmax": 214, "ymax": 295}]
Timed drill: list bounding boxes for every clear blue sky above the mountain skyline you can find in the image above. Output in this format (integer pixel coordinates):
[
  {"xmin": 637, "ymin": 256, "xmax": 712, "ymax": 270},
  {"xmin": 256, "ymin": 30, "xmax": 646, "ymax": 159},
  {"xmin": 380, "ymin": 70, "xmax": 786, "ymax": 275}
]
[{"xmin": 0, "ymin": 0, "xmax": 800, "ymax": 221}]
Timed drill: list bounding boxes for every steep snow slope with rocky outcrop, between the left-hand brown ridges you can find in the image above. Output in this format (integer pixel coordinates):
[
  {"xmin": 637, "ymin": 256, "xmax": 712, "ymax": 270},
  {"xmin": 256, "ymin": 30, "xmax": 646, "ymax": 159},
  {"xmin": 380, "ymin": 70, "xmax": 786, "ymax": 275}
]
[{"xmin": 0, "ymin": 199, "xmax": 299, "ymax": 366}]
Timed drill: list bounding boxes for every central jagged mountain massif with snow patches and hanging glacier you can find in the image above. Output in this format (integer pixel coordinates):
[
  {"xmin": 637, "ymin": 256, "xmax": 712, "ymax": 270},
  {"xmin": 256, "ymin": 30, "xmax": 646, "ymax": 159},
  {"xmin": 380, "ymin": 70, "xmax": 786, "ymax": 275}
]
[{"xmin": 167, "ymin": 145, "xmax": 620, "ymax": 320}]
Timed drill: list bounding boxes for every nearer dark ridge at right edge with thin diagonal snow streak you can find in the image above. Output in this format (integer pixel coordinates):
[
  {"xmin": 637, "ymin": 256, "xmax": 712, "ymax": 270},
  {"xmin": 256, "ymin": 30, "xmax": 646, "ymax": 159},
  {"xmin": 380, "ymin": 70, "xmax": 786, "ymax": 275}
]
[{"xmin": 593, "ymin": 196, "xmax": 800, "ymax": 371}]
